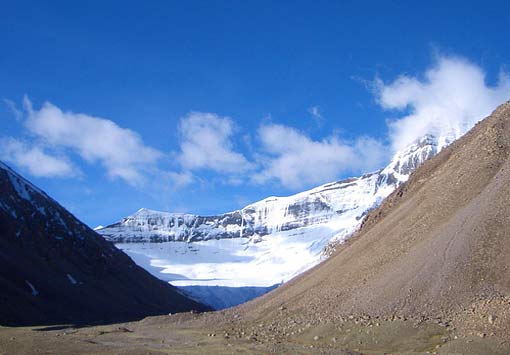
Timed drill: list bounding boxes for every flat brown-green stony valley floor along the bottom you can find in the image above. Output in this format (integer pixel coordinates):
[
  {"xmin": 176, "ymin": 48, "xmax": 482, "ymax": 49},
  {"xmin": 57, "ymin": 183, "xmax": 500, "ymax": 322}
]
[{"xmin": 0, "ymin": 311, "xmax": 510, "ymax": 355}]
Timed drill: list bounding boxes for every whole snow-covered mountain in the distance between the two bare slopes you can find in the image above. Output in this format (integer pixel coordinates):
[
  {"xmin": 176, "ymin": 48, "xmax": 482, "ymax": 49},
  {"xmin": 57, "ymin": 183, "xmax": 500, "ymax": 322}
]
[{"xmin": 97, "ymin": 135, "xmax": 453, "ymax": 304}]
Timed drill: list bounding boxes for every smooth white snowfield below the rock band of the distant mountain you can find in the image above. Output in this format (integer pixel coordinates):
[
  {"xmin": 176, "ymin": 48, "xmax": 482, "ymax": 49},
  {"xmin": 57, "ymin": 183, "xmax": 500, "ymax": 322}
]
[{"xmin": 117, "ymin": 227, "xmax": 332, "ymax": 287}]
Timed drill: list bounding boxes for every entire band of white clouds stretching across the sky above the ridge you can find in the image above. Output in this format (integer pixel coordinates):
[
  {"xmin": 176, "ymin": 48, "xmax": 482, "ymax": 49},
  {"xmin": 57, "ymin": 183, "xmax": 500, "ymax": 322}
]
[{"xmin": 0, "ymin": 56, "xmax": 510, "ymax": 196}]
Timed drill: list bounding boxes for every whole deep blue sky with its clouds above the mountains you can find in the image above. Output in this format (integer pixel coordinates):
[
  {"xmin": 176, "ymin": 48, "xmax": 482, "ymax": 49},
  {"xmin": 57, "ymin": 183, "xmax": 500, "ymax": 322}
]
[{"xmin": 0, "ymin": 1, "xmax": 510, "ymax": 226}]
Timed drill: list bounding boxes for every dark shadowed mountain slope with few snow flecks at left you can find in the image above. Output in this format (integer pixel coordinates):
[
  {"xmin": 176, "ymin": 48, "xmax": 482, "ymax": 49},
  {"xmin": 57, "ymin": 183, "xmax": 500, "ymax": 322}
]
[{"xmin": 0, "ymin": 163, "xmax": 206, "ymax": 325}]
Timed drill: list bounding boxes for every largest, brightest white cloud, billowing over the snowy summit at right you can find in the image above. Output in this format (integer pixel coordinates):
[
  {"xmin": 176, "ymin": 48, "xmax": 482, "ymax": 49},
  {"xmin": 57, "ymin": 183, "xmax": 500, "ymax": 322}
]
[{"xmin": 375, "ymin": 56, "xmax": 510, "ymax": 151}]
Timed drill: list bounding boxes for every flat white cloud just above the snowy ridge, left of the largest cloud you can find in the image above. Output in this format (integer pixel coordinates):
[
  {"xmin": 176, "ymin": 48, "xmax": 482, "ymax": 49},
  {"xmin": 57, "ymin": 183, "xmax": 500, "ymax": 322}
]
[{"xmin": 253, "ymin": 124, "xmax": 385, "ymax": 188}]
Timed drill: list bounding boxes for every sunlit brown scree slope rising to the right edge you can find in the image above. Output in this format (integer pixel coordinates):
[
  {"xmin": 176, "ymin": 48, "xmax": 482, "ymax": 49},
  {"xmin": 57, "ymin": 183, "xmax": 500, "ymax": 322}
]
[{"xmin": 239, "ymin": 103, "xmax": 510, "ymax": 337}]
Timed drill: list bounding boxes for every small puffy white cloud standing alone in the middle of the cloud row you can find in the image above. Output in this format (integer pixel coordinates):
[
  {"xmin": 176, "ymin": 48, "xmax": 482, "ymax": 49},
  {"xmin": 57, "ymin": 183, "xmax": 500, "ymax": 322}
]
[{"xmin": 178, "ymin": 112, "xmax": 252, "ymax": 174}]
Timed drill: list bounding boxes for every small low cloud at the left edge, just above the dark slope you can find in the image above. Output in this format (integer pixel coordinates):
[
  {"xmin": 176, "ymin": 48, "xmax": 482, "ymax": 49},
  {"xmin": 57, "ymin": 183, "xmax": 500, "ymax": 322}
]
[{"xmin": 0, "ymin": 138, "xmax": 77, "ymax": 177}]
